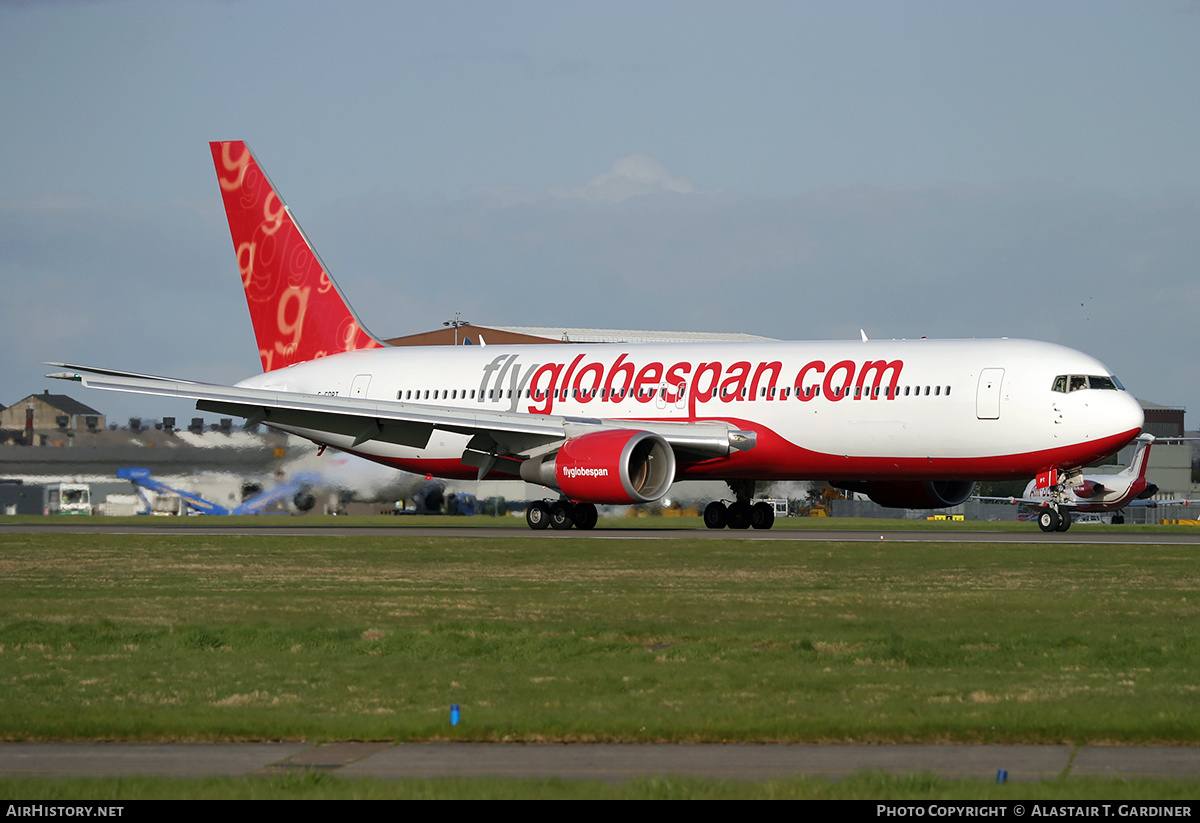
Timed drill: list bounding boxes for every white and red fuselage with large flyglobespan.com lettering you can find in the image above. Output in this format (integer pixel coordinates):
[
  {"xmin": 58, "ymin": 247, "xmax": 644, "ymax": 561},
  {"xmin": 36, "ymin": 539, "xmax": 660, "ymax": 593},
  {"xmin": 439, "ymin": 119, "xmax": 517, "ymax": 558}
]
[{"xmin": 239, "ymin": 340, "xmax": 1142, "ymax": 480}]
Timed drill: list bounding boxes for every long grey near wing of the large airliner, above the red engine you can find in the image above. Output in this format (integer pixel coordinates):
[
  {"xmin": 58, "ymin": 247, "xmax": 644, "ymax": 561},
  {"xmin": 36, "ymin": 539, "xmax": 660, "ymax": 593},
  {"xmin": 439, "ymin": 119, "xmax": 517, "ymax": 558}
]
[{"xmin": 47, "ymin": 364, "xmax": 756, "ymax": 473}]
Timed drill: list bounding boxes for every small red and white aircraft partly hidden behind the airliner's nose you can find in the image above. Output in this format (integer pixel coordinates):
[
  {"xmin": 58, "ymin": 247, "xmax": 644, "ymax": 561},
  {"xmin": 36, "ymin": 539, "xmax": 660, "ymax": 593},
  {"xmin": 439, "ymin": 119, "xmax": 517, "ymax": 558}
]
[{"xmin": 974, "ymin": 434, "xmax": 1200, "ymax": 531}]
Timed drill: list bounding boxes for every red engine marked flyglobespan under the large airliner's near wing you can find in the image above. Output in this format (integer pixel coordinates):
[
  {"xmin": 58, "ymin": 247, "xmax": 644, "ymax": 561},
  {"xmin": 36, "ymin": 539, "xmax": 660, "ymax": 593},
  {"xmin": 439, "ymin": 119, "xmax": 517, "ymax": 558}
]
[{"xmin": 521, "ymin": 428, "xmax": 676, "ymax": 504}]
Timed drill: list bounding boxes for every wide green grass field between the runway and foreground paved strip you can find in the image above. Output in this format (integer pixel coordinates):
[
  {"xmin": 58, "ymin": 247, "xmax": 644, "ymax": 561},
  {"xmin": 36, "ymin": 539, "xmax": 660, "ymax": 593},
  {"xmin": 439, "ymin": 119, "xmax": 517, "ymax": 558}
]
[{"xmin": 0, "ymin": 527, "xmax": 1200, "ymax": 743}]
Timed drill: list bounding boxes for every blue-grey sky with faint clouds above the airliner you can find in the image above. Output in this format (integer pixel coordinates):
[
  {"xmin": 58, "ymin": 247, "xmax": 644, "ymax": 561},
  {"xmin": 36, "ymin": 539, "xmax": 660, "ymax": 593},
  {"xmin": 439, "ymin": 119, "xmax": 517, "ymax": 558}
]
[{"xmin": 0, "ymin": 0, "xmax": 1200, "ymax": 428}]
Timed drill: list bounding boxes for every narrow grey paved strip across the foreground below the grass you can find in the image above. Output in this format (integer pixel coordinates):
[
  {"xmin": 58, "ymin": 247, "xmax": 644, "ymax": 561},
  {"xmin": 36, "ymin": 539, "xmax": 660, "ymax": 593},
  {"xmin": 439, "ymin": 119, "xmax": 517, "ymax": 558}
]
[{"xmin": 0, "ymin": 741, "xmax": 1200, "ymax": 782}]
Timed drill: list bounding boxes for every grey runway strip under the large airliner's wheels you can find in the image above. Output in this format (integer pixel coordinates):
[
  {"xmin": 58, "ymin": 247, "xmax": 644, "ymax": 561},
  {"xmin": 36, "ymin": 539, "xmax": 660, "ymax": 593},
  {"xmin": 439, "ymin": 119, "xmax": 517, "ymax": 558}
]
[{"xmin": 0, "ymin": 525, "xmax": 1200, "ymax": 546}]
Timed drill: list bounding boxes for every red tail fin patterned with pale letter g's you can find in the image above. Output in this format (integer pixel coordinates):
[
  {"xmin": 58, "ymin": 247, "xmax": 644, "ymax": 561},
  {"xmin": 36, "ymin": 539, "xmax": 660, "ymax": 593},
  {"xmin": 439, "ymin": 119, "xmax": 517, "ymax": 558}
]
[{"xmin": 209, "ymin": 140, "xmax": 383, "ymax": 372}]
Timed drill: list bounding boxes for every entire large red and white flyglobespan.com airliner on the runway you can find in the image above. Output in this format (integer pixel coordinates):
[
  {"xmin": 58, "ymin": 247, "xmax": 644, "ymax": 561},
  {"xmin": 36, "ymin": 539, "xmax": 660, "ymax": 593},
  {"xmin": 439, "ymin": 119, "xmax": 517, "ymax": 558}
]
[{"xmin": 52, "ymin": 143, "xmax": 1142, "ymax": 529}]
